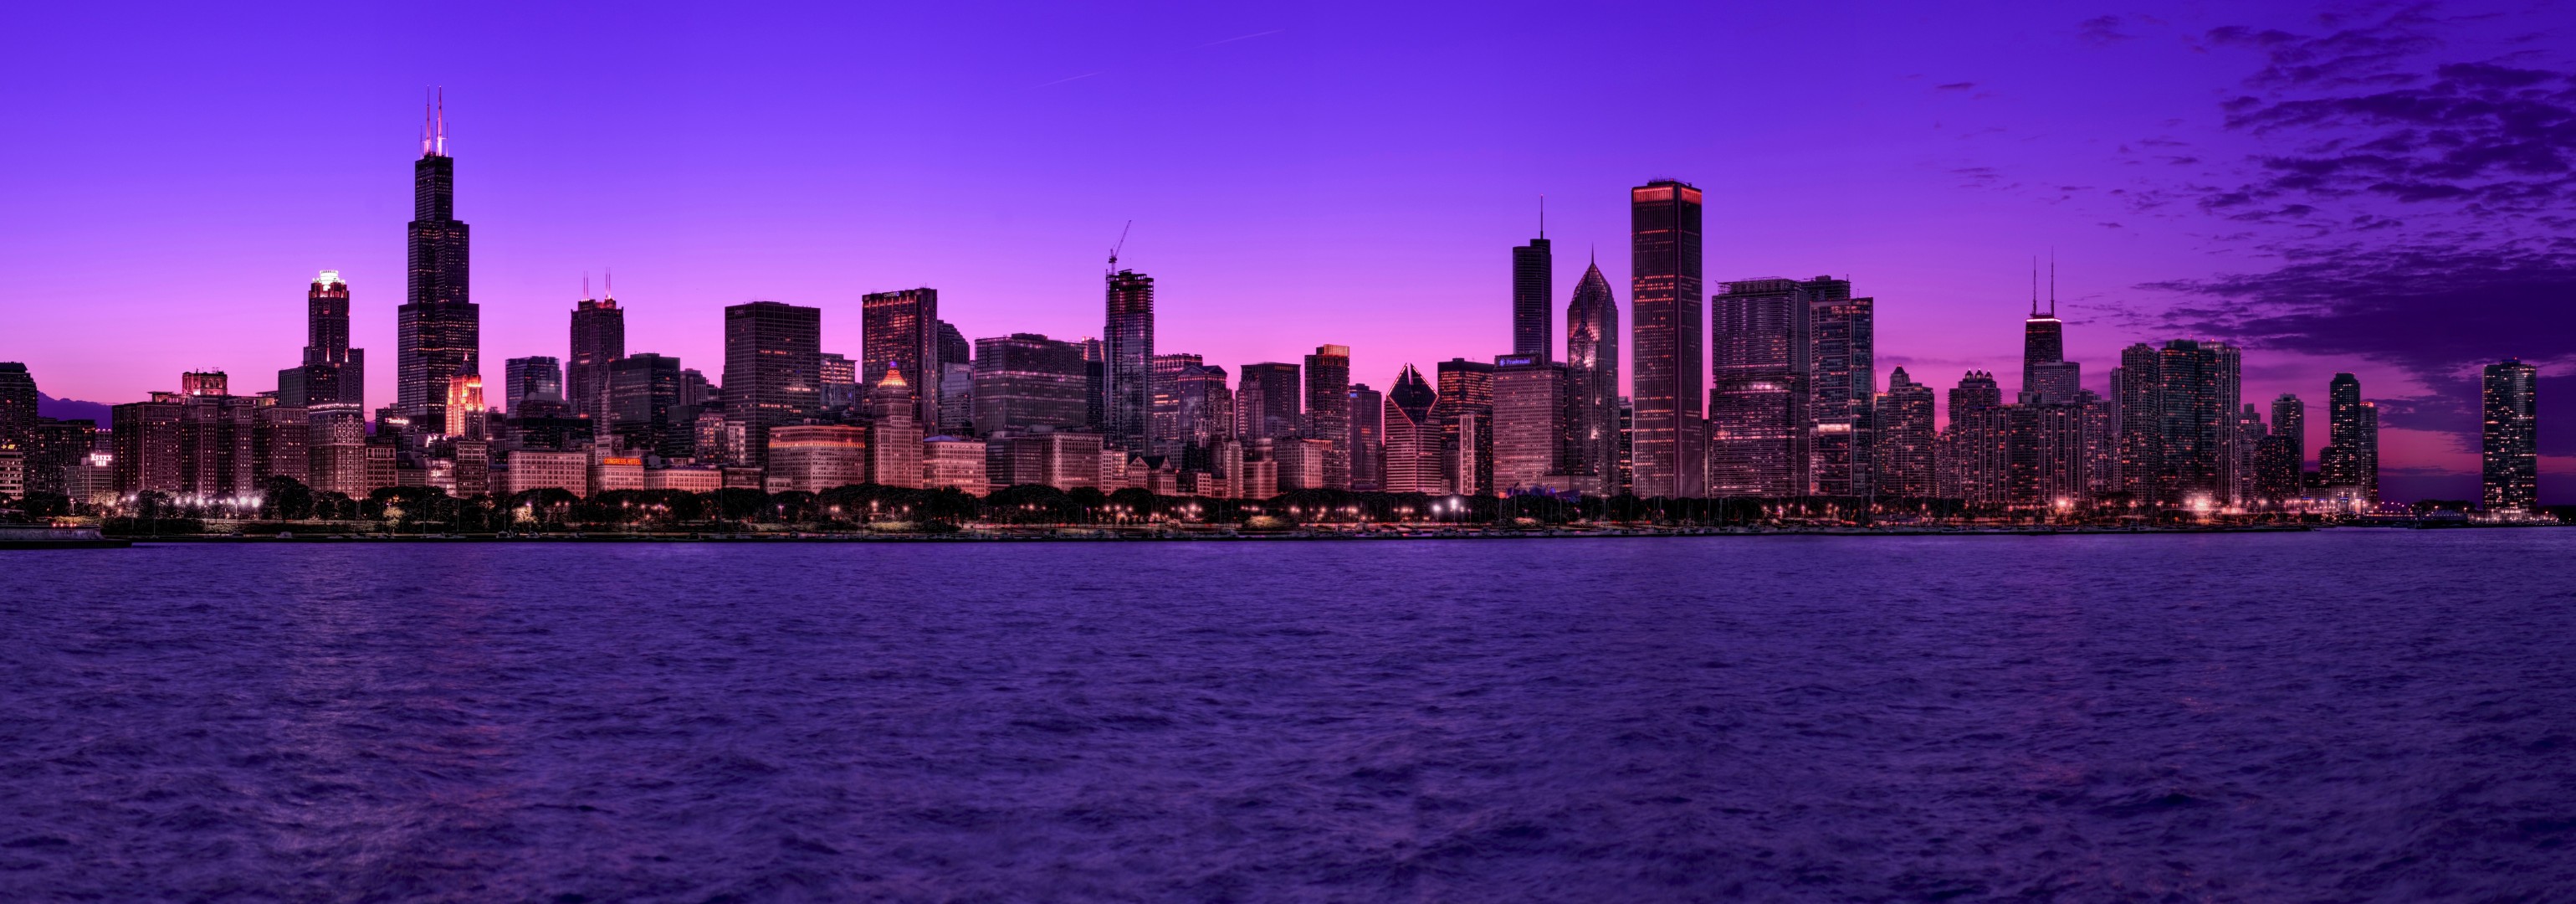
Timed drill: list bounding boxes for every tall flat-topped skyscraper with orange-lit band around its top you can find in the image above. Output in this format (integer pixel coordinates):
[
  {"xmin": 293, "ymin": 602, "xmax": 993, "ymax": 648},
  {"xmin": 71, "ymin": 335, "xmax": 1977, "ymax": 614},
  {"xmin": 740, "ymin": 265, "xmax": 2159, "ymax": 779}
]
[{"xmin": 1628, "ymin": 180, "xmax": 1708, "ymax": 497}]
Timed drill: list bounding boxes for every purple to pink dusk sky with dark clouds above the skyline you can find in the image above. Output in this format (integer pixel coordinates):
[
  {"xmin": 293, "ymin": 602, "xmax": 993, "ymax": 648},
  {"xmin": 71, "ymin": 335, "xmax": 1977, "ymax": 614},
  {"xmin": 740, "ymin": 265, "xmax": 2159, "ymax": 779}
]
[{"xmin": 0, "ymin": 3, "xmax": 2576, "ymax": 502}]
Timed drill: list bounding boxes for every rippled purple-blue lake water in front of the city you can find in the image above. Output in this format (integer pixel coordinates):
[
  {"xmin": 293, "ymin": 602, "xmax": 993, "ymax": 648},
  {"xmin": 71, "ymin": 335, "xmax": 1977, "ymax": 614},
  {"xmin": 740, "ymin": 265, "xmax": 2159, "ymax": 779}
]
[{"xmin": 0, "ymin": 531, "xmax": 2576, "ymax": 901}]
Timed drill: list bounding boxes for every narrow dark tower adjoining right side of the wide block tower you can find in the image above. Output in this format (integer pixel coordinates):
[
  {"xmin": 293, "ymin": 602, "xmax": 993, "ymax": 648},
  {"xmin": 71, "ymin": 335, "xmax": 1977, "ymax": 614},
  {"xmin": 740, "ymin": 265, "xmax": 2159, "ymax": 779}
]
[{"xmin": 1805, "ymin": 288, "xmax": 1878, "ymax": 497}]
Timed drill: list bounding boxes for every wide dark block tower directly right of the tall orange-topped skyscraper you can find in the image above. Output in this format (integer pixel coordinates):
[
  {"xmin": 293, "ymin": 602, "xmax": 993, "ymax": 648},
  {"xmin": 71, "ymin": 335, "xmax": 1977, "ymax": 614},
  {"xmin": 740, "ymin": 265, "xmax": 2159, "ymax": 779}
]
[{"xmin": 1708, "ymin": 275, "xmax": 1850, "ymax": 497}]
